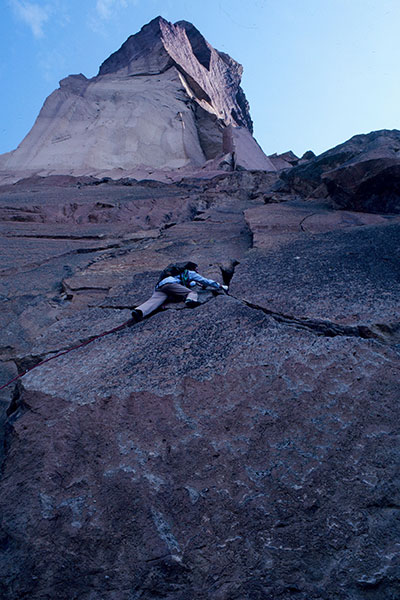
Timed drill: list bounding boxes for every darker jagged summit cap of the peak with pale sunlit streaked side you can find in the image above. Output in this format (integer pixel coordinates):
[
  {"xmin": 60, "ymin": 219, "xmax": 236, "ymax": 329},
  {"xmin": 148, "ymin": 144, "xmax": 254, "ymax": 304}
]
[{"xmin": 98, "ymin": 17, "xmax": 253, "ymax": 133}]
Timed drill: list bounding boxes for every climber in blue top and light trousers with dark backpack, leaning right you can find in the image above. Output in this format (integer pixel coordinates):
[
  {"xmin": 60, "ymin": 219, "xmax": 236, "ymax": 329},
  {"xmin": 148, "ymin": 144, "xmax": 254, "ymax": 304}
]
[{"xmin": 128, "ymin": 261, "xmax": 228, "ymax": 325}]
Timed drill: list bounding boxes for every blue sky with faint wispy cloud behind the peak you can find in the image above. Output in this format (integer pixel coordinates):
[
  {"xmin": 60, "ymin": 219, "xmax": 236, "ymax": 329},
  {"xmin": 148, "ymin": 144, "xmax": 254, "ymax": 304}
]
[{"xmin": 0, "ymin": 0, "xmax": 400, "ymax": 155}]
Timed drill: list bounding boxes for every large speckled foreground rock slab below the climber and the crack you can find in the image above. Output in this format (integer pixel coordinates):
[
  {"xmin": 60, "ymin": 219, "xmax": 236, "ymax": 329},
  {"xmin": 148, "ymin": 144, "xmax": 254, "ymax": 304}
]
[{"xmin": 0, "ymin": 297, "xmax": 400, "ymax": 600}]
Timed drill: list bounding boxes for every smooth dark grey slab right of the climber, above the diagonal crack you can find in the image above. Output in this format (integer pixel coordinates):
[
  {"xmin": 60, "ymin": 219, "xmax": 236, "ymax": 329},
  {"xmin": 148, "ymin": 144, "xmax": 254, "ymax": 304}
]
[{"xmin": 230, "ymin": 218, "xmax": 400, "ymax": 335}]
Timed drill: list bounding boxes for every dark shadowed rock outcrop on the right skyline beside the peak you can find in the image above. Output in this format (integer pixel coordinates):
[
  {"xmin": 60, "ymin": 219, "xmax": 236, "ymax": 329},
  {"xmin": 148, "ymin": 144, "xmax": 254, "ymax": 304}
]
[{"xmin": 278, "ymin": 130, "xmax": 400, "ymax": 213}]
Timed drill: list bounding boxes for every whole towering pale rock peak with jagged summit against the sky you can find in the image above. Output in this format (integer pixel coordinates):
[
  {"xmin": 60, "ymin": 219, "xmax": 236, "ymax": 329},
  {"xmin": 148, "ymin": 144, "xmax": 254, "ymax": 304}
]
[{"xmin": 0, "ymin": 17, "xmax": 275, "ymax": 181}]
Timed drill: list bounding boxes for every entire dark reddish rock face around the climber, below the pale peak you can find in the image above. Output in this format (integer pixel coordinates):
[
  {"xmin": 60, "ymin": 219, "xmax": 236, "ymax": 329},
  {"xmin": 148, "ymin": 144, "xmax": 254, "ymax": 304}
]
[{"xmin": 0, "ymin": 170, "xmax": 400, "ymax": 600}]
